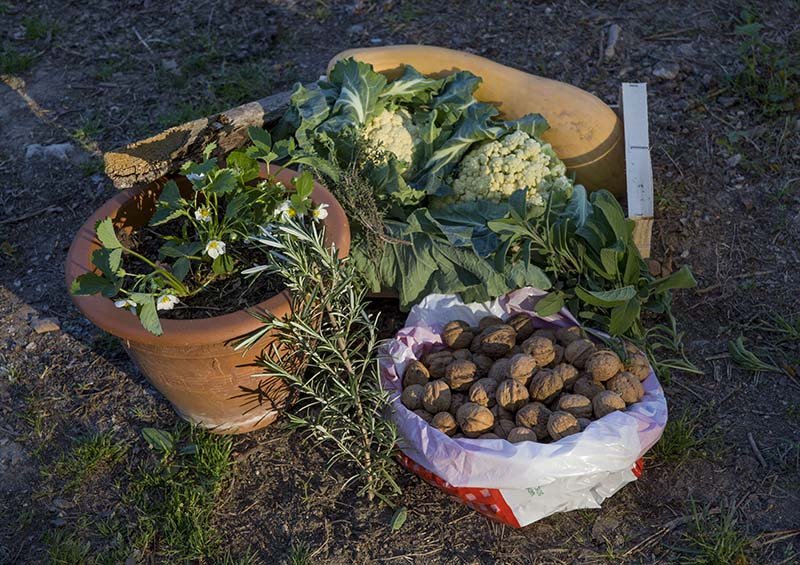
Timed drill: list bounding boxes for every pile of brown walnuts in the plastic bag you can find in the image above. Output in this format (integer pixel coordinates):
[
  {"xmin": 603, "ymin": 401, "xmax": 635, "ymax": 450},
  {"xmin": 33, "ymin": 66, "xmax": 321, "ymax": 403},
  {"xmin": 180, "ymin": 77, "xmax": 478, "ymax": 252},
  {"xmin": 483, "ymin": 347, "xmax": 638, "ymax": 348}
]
[{"xmin": 402, "ymin": 314, "xmax": 650, "ymax": 443}]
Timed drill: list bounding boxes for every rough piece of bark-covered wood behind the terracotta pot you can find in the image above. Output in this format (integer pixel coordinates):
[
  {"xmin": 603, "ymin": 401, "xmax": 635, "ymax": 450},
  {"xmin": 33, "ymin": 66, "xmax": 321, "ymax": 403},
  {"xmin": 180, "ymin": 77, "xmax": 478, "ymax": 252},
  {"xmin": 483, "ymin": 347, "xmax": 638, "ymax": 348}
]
[{"xmin": 104, "ymin": 91, "xmax": 291, "ymax": 189}]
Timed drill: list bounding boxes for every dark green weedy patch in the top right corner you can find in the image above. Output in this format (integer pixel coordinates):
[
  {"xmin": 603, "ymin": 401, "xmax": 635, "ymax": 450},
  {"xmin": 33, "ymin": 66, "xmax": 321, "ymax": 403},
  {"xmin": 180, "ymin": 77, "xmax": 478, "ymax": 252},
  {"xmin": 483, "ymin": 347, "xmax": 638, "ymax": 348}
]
[{"xmin": 728, "ymin": 9, "xmax": 800, "ymax": 115}]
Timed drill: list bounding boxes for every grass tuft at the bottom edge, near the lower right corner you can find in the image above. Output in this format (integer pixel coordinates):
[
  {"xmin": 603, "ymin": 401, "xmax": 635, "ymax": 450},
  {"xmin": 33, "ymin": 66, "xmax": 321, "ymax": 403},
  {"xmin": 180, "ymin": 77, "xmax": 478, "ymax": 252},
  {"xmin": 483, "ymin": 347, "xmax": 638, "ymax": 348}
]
[{"xmin": 681, "ymin": 501, "xmax": 754, "ymax": 565}]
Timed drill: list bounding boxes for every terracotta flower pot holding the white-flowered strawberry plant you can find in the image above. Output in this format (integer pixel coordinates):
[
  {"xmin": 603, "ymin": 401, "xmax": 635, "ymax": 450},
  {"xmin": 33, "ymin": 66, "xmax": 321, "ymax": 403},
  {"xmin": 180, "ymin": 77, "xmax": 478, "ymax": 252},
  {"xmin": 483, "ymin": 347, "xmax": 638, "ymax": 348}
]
[{"xmin": 66, "ymin": 163, "xmax": 350, "ymax": 434}]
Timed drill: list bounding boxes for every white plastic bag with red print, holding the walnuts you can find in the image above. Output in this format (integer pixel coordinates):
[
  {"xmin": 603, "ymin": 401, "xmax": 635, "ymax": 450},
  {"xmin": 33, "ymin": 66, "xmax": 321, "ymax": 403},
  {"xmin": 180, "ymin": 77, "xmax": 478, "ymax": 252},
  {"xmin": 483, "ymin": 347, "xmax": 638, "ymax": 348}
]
[{"xmin": 381, "ymin": 288, "xmax": 667, "ymax": 527}]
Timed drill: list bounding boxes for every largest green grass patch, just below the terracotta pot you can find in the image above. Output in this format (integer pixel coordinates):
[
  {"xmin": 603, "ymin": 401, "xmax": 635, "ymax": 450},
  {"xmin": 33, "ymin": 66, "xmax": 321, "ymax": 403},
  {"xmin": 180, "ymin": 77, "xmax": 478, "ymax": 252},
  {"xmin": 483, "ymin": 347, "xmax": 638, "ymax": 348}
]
[{"xmin": 123, "ymin": 425, "xmax": 232, "ymax": 562}]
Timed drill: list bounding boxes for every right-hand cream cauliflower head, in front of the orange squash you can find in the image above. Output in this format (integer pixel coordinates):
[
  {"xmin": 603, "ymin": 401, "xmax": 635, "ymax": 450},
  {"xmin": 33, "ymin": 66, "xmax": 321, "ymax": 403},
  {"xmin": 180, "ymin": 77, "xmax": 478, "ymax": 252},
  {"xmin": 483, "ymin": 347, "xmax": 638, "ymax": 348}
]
[{"xmin": 453, "ymin": 130, "xmax": 572, "ymax": 206}]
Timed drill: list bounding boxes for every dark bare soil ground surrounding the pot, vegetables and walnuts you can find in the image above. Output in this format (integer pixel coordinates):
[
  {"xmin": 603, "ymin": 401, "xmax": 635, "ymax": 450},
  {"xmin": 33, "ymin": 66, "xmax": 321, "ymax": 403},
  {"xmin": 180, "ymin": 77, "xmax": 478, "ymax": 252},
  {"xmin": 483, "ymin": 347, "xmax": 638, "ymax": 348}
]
[{"xmin": 0, "ymin": 0, "xmax": 800, "ymax": 563}]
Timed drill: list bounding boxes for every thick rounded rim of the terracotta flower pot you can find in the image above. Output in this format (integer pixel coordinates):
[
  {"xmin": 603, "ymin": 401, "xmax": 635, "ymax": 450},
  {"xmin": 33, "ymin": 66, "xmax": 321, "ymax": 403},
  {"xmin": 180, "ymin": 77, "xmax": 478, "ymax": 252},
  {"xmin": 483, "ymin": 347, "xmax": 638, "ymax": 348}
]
[{"xmin": 64, "ymin": 164, "xmax": 350, "ymax": 347}]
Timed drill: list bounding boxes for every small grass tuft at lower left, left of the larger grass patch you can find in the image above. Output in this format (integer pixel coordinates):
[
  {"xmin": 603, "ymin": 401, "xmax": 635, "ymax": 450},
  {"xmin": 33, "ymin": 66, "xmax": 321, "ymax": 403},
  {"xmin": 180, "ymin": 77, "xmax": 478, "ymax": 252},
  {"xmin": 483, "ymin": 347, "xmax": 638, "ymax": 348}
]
[{"xmin": 53, "ymin": 432, "xmax": 128, "ymax": 490}]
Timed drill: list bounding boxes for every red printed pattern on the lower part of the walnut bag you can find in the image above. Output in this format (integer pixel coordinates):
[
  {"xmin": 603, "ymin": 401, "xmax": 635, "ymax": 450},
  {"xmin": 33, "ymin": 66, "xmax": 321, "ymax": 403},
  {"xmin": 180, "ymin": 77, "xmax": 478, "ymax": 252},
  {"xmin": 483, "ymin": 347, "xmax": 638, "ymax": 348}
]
[{"xmin": 397, "ymin": 452, "xmax": 644, "ymax": 528}]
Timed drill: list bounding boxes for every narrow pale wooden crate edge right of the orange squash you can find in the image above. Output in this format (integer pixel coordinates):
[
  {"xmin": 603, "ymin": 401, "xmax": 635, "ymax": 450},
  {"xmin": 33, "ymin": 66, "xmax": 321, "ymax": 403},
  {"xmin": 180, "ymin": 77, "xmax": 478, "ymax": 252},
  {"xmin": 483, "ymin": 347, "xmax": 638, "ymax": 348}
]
[{"xmin": 620, "ymin": 82, "xmax": 654, "ymax": 259}]
